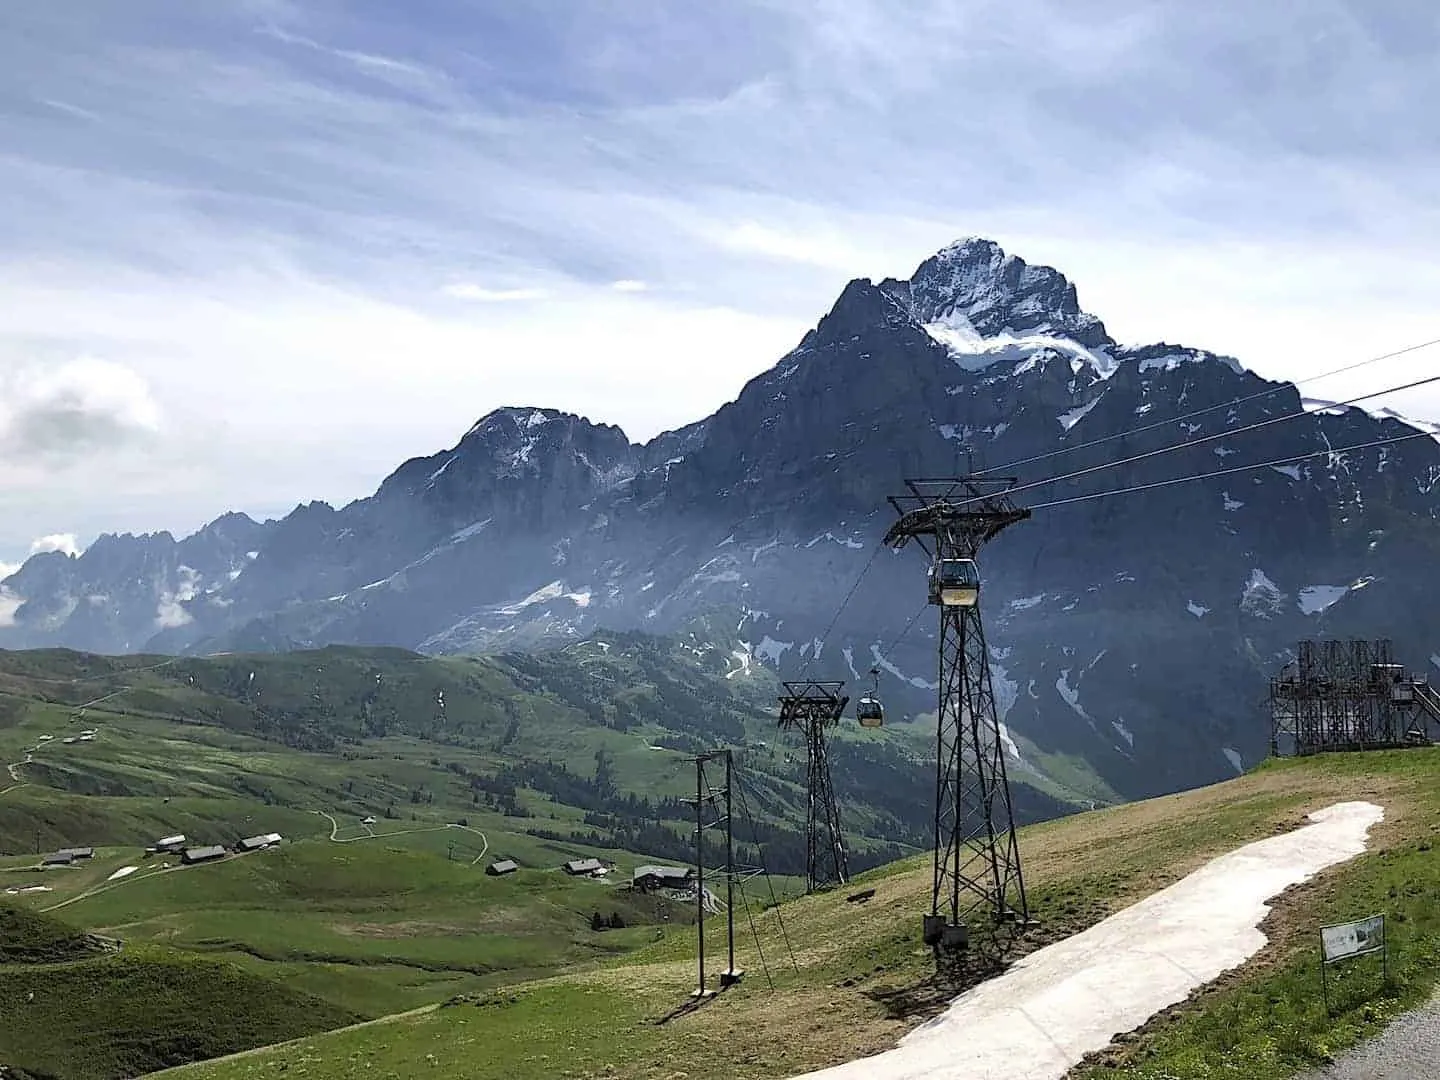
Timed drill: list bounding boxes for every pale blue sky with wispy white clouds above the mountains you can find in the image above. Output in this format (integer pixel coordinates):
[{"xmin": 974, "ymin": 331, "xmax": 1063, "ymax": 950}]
[{"xmin": 0, "ymin": 0, "xmax": 1440, "ymax": 563}]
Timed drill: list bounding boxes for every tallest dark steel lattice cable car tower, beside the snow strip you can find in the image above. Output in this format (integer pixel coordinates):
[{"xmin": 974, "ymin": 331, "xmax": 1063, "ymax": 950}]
[{"xmin": 884, "ymin": 475, "xmax": 1030, "ymax": 966}]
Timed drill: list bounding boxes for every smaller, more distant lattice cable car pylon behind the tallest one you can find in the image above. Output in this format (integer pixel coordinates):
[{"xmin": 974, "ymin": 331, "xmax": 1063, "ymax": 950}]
[{"xmin": 780, "ymin": 681, "xmax": 850, "ymax": 893}]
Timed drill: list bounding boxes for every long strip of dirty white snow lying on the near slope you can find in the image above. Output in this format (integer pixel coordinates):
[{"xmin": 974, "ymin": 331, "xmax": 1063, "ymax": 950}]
[{"xmin": 805, "ymin": 802, "xmax": 1384, "ymax": 1080}]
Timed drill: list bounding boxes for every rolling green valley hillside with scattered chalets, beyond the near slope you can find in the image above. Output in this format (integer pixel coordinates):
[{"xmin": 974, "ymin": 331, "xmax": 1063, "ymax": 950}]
[{"xmin": 0, "ymin": 635, "xmax": 1082, "ymax": 1080}]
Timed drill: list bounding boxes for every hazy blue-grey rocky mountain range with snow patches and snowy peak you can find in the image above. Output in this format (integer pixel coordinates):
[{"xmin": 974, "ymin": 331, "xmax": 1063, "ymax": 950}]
[{"xmin": 0, "ymin": 239, "xmax": 1440, "ymax": 798}]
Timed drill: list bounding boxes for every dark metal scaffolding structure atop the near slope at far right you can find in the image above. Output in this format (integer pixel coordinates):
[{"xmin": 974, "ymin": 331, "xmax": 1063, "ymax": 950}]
[{"xmin": 1270, "ymin": 639, "xmax": 1440, "ymax": 756}]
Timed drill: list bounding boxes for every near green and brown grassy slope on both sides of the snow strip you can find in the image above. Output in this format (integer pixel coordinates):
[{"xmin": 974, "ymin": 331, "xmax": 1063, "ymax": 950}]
[{"xmin": 163, "ymin": 750, "xmax": 1440, "ymax": 1080}]
